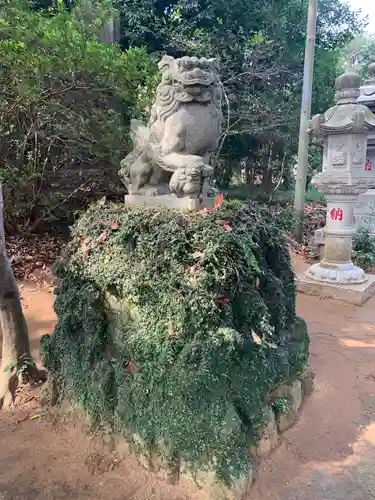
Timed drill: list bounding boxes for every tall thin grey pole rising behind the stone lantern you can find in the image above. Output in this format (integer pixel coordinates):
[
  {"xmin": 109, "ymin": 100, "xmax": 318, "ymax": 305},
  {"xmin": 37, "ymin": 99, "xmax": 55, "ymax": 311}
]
[{"xmin": 294, "ymin": 0, "xmax": 317, "ymax": 241}]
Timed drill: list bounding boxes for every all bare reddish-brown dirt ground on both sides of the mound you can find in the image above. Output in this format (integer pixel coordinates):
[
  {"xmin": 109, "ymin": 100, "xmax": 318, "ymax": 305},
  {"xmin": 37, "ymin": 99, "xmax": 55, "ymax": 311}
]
[{"xmin": 0, "ymin": 258, "xmax": 375, "ymax": 500}]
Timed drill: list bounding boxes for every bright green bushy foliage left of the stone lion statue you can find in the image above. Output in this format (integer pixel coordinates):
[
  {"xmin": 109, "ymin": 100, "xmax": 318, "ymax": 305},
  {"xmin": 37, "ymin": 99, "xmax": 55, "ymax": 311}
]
[{"xmin": 0, "ymin": 0, "xmax": 156, "ymax": 231}]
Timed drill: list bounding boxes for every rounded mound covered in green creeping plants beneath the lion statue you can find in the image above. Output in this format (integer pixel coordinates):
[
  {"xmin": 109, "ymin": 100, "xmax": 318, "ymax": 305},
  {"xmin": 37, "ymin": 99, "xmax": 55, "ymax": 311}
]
[{"xmin": 42, "ymin": 199, "xmax": 308, "ymax": 483}]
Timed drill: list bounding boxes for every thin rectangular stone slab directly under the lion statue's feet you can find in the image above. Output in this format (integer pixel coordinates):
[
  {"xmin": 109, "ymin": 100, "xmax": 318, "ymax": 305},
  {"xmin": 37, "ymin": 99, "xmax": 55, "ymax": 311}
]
[{"xmin": 125, "ymin": 194, "xmax": 214, "ymax": 211}]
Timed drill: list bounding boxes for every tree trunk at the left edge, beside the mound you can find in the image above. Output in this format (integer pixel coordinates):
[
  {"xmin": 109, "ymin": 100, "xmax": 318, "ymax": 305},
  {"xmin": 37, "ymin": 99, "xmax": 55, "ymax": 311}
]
[{"xmin": 0, "ymin": 185, "xmax": 37, "ymax": 408}]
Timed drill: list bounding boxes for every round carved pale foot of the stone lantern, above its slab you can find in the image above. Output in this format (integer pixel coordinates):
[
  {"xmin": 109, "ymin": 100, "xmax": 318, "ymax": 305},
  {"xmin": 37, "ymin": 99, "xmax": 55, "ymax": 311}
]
[{"xmin": 306, "ymin": 262, "xmax": 368, "ymax": 285}]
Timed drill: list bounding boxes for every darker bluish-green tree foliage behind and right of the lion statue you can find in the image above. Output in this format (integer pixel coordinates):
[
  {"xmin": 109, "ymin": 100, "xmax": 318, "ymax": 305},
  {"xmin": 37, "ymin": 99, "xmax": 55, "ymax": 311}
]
[{"xmin": 116, "ymin": 0, "xmax": 362, "ymax": 190}]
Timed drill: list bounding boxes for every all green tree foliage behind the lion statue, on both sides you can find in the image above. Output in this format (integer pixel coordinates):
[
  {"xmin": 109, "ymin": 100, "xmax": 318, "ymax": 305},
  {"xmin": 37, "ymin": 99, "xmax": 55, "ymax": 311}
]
[{"xmin": 0, "ymin": 0, "xmax": 366, "ymax": 231}]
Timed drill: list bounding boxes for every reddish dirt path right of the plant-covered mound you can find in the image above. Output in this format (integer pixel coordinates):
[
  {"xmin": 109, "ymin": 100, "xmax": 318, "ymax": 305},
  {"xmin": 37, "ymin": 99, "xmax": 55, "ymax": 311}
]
[{"xmin": 250, "ymin": 295, "xmax": 375, "ymax": 500}]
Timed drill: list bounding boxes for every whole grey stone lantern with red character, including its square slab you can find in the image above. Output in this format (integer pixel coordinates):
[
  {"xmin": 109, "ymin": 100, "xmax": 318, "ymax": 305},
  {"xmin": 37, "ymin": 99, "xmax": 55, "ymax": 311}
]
[{"xmin": 298, "ymin": 73, "xmax": 375, "ymax": 304}]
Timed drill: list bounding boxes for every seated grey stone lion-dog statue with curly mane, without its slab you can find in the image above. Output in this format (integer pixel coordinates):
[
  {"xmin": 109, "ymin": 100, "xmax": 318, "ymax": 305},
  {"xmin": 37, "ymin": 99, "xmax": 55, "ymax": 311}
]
[{"xmin": 119, "ymin": 56, "xmax": 222, "ymax": 199}]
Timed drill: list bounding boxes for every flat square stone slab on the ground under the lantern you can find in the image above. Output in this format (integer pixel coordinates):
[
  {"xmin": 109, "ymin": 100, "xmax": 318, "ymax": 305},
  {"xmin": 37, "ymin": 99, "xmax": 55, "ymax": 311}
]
[{"xmin": 296, "ymin": 273, "xmax": 375, "ymax": 306}]
